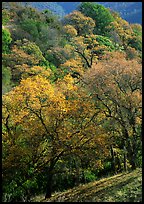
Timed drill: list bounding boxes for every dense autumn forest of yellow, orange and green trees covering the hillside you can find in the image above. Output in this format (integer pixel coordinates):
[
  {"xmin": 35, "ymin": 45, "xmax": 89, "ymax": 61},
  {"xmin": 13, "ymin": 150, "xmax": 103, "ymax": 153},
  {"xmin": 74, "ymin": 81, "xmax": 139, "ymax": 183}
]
[{"xmin": 2, "ymin": 2, "xmax": 142, "ymax": 202}]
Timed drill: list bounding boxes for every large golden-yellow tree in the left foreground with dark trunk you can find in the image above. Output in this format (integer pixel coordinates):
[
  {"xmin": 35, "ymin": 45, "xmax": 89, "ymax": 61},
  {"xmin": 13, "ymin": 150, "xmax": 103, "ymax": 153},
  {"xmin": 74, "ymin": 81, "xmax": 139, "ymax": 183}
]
[{"xmin": 2, "ymin": 75, "xmax": 105, "ymax": 198}]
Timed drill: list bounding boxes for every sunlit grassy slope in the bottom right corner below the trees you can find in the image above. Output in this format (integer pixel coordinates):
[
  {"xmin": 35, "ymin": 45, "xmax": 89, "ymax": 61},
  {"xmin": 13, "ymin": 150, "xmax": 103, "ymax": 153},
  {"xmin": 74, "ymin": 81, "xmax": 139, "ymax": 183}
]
[{"xmin": 32, "ymin": 169, "xmax": 142, "ymax": 202}]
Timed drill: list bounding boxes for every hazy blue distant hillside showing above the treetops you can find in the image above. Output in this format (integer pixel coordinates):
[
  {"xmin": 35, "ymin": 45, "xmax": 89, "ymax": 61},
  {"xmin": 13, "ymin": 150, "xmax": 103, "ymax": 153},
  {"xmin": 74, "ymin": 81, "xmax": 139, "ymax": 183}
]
[{"xmin": 23, "ymin": 2, "xmax": 142, "ymax": 24}]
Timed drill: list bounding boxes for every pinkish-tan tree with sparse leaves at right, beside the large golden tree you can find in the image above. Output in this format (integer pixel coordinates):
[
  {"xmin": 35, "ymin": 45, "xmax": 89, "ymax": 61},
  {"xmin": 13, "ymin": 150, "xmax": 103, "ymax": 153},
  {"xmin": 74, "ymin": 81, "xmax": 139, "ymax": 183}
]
[{"xmin": 84, "ymin": 52, "xmax": 142, "ymax": 171}]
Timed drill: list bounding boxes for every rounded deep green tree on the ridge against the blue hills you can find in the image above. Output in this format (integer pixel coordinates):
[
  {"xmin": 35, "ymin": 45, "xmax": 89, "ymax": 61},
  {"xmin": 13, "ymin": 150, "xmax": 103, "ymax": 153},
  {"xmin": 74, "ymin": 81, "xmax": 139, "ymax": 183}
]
[{"xmin": 78, "ymin": 2, "xmax": 114, "ymax": 35}]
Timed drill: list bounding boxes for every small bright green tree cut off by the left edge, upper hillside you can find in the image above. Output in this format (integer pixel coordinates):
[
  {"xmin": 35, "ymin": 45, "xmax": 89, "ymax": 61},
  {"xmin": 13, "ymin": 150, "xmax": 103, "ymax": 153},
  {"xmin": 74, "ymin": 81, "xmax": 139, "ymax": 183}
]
[{"xmin": 2, "ymin": 29, "xmax": 12, "ymax": 53}]
